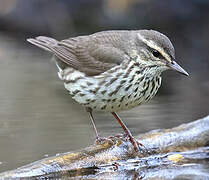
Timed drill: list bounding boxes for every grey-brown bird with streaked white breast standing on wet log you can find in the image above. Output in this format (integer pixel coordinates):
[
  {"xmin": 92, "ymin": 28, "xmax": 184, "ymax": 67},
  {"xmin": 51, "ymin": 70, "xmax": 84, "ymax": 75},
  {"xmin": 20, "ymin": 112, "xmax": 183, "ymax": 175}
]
[{"xmin": 27, "ymin": 29, "xmax": 189, "ymax": 152}]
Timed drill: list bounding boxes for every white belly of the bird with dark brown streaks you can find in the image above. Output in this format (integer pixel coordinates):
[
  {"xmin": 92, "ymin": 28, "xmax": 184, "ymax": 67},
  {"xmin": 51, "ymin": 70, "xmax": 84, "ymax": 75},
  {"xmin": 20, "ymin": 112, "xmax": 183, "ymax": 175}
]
[{"xmin": 60, "ymin": 65, "xmax": 161, "ymax": 112}]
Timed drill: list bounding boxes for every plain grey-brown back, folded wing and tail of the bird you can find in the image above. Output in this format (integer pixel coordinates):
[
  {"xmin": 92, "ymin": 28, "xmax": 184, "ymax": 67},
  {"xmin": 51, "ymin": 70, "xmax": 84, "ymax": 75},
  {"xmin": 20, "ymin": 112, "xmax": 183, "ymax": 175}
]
[{"xmin": 28, "ymin": 31, "xmax": 131, "ymax": 76}]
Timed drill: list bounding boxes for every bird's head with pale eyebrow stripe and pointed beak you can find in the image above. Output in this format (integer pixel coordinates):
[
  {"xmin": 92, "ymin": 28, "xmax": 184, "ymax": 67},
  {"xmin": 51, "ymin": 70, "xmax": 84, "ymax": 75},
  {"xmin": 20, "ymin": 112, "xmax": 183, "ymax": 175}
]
[{"xmin": 136, "ymin": 30, "xmax": 189, "ymax": 76}]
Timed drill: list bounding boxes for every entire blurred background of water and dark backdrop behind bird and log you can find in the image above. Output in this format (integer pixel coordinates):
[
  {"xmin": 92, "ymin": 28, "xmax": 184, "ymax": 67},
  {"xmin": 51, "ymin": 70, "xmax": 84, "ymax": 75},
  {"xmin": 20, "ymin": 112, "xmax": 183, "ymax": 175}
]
[{"xmin": 0, "ymin": 0, "xmax": 209, "ymax": 172}]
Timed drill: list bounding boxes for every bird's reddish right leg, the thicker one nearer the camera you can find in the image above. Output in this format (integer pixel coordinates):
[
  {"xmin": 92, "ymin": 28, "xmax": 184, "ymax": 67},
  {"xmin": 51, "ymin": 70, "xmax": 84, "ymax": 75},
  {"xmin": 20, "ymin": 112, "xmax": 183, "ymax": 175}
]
[{"xmin": 112, "ymin": 112, "xmax": 144, "ymax": 152}]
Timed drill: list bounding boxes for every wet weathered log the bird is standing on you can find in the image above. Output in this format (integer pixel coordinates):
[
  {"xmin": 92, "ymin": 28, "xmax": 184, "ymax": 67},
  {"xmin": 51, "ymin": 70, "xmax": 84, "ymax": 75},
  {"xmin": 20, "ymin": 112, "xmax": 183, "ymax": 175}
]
[{"xmin": 0, "ymin": 116, "xmax": 209, "ymax": 179}]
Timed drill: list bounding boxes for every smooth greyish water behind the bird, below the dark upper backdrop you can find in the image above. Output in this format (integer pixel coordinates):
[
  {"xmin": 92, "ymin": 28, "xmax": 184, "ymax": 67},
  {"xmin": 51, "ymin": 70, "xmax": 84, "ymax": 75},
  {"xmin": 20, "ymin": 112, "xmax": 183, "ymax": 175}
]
[{"xmin": 0, "ymin": 33, "xmax": 209, "ymax": 172}]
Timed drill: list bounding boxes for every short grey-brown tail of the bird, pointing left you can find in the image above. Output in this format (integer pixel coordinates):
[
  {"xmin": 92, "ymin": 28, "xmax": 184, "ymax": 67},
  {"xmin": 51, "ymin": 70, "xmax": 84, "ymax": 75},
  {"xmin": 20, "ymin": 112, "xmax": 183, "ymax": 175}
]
[{"xmin": 27, "ymin": 36, "xmax": 58, "ymax": 52}]
